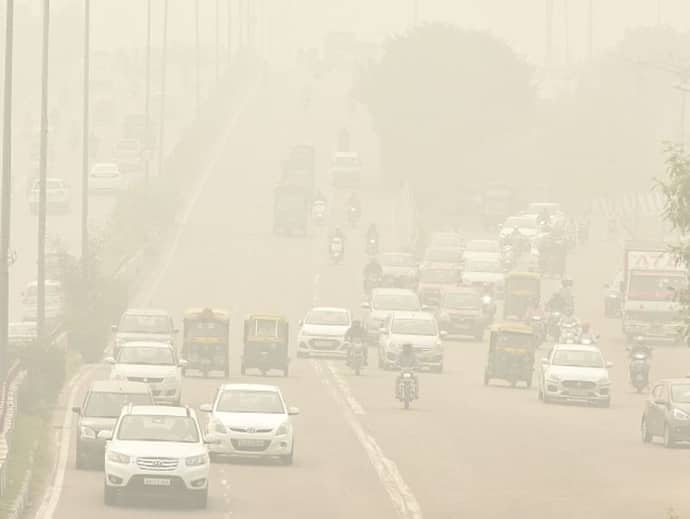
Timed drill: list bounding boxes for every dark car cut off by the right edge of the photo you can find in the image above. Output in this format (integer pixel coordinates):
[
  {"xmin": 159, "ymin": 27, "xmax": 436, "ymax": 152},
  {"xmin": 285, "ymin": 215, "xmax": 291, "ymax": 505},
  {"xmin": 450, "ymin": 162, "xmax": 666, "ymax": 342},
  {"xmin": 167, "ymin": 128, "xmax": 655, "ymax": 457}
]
[{"xmin": 640, "ymin": 377, "xmax": 690, "ymax": 448}]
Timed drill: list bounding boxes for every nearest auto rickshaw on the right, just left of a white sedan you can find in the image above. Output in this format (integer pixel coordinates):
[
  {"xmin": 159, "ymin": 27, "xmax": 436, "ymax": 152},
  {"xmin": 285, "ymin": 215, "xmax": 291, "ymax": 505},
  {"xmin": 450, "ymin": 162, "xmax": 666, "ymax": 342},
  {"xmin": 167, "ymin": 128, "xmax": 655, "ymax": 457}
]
[{"xmin": 484, "ymin": 321, "xmax": 537, "ymax": 387}]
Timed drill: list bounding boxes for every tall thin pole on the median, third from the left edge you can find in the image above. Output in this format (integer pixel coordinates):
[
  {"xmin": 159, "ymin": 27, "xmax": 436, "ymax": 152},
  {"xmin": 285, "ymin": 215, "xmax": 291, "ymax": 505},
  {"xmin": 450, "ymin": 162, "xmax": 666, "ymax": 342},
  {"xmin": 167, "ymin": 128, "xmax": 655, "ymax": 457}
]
[{"xmin": 81, "ymin": 0, "xmax": 91, "ymax": 275}]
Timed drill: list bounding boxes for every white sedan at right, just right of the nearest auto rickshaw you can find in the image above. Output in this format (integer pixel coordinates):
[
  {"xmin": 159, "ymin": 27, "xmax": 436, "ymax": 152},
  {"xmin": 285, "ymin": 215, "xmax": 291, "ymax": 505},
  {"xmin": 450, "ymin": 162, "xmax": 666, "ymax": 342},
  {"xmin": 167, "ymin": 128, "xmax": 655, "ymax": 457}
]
[{"xmin": 539, "ymin": 344, "xmax": 612, "ymax": 407}]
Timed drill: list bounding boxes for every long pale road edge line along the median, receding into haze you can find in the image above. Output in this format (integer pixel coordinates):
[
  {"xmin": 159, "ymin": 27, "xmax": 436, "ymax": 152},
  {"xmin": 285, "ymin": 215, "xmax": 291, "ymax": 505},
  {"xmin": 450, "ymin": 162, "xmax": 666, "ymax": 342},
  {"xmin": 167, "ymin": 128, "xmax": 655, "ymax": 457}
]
[{"xmin": 143, "ymin": 88, "xmax": 259, "ymax": 304}]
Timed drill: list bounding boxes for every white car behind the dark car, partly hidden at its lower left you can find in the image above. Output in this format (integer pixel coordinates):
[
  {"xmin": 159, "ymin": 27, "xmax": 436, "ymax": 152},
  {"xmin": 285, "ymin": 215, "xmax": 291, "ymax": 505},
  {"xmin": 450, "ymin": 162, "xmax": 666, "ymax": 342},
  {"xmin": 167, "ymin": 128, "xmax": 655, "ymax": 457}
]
[{"xmin": 105, "ymin": 341, "xmax": 187, "ymax": 405}]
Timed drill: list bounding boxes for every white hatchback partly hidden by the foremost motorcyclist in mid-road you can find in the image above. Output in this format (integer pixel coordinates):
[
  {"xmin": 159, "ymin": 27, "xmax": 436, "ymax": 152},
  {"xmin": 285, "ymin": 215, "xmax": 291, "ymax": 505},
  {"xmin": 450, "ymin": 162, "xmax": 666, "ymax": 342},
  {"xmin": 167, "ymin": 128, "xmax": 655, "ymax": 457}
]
[{"xmin": 378, "ymin": 312, "xmax": 447, "ymax": 373}]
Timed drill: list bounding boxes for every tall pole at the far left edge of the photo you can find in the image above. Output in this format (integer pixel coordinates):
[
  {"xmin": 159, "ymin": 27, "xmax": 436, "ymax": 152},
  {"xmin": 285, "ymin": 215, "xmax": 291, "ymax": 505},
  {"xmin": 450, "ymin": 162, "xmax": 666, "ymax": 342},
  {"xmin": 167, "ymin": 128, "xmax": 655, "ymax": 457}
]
[{"xmin": 0, "ymin": 0, "xmax": 14, "ymax": 380}]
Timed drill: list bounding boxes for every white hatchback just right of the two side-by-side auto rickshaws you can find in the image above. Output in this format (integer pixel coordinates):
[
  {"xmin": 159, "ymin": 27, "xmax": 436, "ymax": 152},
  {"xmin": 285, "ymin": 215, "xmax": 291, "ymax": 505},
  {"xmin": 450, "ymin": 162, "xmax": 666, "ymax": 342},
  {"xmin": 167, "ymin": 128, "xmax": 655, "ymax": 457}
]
[{"xmin": 297, "ymin": 307, "xmax": 352, "ymax": 357}]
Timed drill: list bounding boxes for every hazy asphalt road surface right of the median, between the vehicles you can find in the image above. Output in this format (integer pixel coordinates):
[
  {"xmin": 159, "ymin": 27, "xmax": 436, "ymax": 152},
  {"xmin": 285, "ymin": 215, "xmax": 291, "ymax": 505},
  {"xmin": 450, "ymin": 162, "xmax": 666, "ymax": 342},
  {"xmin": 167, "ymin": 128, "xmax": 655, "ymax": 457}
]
[{"xmin": 40, "ymin": 65, "xmax": 690, "ymax": 519}]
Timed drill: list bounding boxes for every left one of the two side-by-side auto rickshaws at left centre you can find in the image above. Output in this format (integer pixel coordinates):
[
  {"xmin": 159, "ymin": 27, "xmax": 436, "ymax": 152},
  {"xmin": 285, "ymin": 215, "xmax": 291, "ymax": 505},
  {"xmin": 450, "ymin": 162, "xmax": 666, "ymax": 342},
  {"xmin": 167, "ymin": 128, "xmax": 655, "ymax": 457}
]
[{"xmin": 181, "ymin": 308, "xmax": 230, "ymax": 377}]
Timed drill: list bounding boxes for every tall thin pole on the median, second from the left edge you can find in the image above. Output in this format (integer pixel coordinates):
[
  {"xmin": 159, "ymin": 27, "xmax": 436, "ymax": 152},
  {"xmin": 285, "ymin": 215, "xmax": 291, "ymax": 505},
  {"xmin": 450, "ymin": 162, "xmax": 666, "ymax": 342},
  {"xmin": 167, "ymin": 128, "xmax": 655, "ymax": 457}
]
[{"xmin": 36, "ymin": 0, "xmax": 50, "ymax": 346}]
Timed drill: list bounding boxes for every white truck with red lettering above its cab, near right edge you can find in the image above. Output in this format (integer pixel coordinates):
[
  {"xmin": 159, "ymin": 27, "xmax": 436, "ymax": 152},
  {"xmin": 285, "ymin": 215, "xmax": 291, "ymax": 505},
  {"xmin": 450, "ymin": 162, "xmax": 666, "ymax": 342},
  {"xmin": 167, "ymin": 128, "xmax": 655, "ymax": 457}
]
[{"xmin": 621, "ymin": 241, "xmax": 688, "ymax": 342}]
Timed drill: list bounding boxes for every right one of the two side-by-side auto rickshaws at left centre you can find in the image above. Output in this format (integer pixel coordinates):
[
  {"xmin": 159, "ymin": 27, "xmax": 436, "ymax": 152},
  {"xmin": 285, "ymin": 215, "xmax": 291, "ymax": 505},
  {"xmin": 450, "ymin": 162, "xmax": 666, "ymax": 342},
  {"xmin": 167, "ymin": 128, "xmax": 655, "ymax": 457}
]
[{"xmin": 240, "ymin": 314, "xmax": 290, "ymax": 377}]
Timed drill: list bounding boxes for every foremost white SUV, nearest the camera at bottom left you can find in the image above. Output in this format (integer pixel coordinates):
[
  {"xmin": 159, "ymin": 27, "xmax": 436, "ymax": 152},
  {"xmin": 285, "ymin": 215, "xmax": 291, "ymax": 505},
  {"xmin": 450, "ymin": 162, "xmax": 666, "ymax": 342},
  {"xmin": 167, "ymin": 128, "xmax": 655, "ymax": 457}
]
[{"xmin": 98, "ymin": 405, "xmax": 209, "ymax": 508}]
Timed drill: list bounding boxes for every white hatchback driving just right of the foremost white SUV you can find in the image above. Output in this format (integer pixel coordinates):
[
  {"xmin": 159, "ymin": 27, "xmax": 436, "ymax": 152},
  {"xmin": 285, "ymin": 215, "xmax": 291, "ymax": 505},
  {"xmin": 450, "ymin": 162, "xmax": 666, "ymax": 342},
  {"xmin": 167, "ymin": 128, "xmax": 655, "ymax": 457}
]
[{"xmin": 201, "ymin": 384, "xmax": 299, "ymax": 465}]
